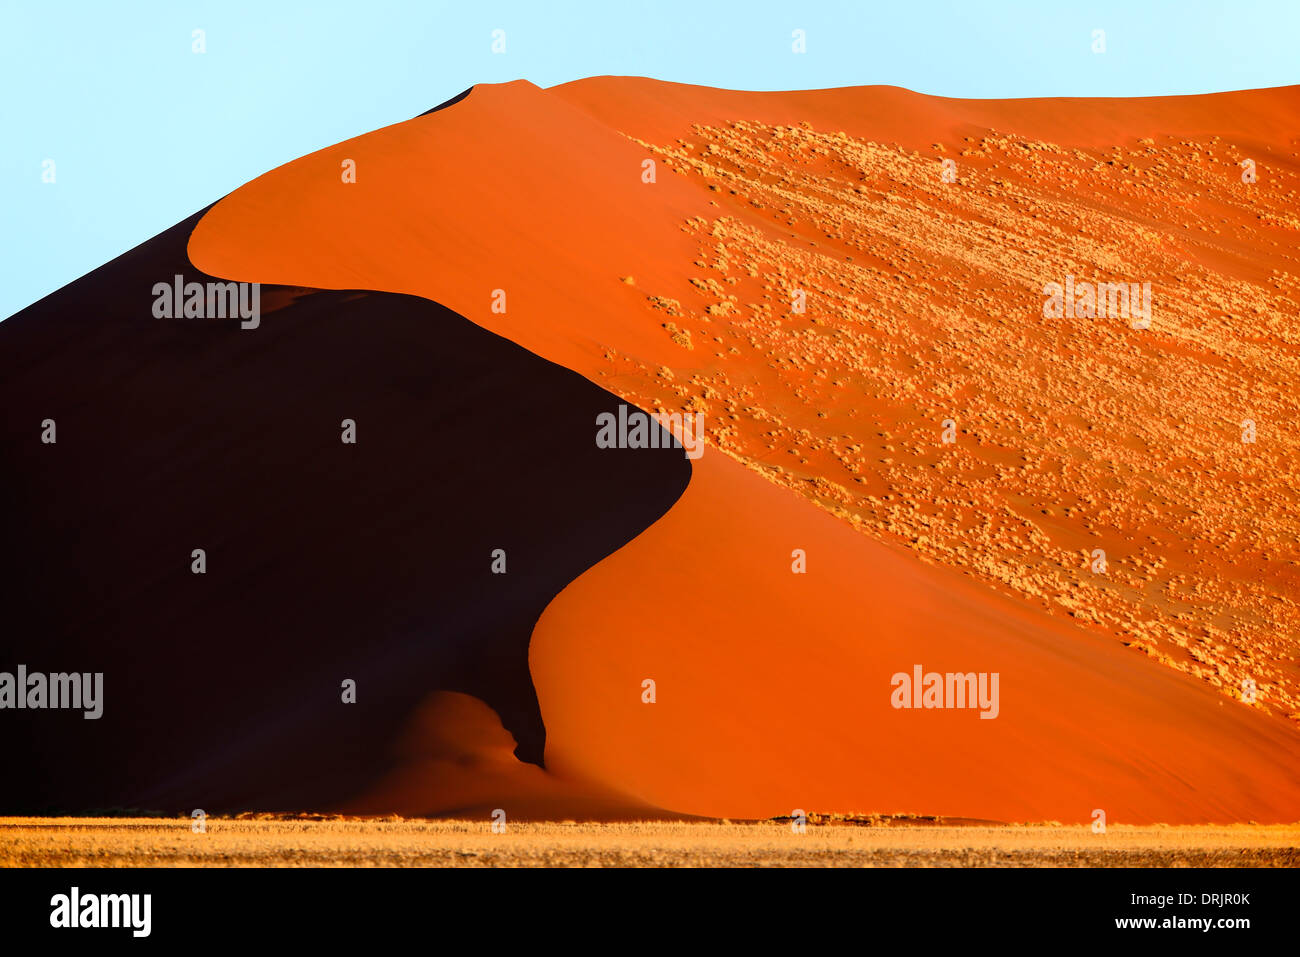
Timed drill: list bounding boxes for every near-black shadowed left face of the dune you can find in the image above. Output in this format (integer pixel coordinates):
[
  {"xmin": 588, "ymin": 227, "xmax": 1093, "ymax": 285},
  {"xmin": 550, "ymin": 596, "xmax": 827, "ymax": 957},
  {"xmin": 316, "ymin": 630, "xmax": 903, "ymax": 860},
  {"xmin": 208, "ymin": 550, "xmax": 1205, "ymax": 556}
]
[{"xmin": 0, "ymin": 213, "xmax": 690, "ymax": 813}]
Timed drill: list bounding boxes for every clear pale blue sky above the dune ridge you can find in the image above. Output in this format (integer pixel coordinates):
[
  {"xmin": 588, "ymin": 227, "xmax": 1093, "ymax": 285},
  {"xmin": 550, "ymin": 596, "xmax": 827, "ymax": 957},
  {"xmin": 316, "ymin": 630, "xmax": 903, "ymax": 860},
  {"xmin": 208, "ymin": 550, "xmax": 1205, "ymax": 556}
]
[{"xmin": 0, "ymin": 0, "xmax": 1300, "ymax": 316}]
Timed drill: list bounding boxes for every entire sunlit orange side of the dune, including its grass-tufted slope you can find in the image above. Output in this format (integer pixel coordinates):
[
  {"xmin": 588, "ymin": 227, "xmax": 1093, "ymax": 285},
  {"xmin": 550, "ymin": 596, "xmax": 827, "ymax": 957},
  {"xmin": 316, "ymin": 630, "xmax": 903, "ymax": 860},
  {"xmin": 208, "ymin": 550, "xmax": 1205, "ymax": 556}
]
[{"xmin": 190, "ymin": 78, "xmax": 1300, "ymax": 823}]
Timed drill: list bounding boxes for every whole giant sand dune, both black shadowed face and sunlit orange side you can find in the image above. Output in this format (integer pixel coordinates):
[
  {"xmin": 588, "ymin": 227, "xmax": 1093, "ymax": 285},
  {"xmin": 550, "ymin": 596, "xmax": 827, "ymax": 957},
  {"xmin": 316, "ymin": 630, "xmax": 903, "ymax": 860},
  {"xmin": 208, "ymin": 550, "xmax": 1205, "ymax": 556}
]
[{"xmin": 0, "ymin": 77, "xmax": 1300, "ymax": 823}]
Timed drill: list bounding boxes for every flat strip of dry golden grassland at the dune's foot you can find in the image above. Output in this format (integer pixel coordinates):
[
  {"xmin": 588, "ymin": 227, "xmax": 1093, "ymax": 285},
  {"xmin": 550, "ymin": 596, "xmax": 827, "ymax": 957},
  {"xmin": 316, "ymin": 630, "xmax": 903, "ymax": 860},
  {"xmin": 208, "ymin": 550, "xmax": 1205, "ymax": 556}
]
[{"xmin": 0, "ymin": 817, "xmax": 1300, "ymax": 867}]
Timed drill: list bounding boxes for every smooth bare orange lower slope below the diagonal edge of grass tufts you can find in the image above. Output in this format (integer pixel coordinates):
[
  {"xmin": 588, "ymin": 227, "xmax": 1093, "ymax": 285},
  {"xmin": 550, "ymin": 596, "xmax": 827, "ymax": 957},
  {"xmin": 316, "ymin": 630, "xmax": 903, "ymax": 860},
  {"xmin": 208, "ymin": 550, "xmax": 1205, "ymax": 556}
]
[{"xmin": 529, "ymin": 454, "xmax": 1296, "ymax": 822}]
